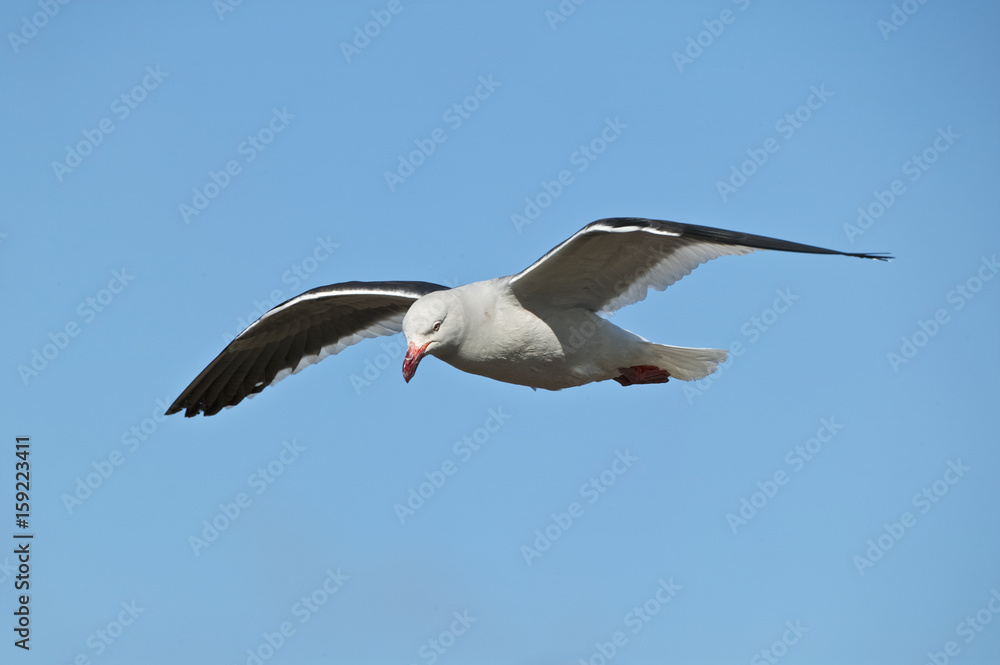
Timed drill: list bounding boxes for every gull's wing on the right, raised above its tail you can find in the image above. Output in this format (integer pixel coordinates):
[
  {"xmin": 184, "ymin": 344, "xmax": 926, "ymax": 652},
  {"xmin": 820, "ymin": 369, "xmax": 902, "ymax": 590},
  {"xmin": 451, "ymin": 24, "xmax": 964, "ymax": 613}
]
[{"xmin": 508, "ymin": 217, "xmax": 892, "ymax": 312}]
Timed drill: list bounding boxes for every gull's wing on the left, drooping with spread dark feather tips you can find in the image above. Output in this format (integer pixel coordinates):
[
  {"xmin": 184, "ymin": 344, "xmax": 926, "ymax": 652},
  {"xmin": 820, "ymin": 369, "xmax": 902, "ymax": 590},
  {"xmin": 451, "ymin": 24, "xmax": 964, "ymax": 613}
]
[{"xmin": 167, "ymin": 282, "xmax": 448, "ymax": 418}]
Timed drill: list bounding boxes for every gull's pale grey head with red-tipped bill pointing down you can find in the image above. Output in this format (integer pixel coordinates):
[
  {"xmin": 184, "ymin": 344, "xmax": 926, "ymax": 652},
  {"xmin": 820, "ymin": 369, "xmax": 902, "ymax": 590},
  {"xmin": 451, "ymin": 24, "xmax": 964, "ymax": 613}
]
[{"xmin": 403, "ymin": 291, "xmax": 462, "ymax": 383}]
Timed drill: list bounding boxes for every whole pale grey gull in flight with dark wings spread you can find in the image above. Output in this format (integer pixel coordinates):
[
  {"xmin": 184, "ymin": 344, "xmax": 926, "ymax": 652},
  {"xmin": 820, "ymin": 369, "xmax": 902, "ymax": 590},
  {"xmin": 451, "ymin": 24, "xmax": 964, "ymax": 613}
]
[{"xmin": 166, "ymin": 217, "xmax": 893, "ymax": 418}]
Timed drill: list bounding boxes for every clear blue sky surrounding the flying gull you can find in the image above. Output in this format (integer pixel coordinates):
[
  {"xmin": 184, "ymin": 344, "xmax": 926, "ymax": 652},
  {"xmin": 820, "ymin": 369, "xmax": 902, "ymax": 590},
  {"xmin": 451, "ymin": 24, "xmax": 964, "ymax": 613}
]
[{"xmin": 0, "ymin": 0, "xmax": 1000, "ymax": 665}]
